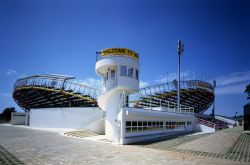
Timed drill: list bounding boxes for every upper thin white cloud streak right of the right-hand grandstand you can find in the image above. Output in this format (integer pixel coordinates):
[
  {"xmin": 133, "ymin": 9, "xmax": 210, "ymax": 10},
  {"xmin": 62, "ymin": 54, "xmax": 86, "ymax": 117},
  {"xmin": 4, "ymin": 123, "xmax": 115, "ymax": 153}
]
[{"xmin": 216, "ymin": 70, "xmax": 250, "ymax": 86}]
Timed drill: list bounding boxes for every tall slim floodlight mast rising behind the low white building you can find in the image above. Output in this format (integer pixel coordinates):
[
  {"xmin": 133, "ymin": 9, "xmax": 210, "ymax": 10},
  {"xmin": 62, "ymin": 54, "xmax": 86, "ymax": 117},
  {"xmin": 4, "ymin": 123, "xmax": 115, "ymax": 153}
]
[{"xmin": 177, "ymin": 40, "xmax": 184, "ymax": 113}]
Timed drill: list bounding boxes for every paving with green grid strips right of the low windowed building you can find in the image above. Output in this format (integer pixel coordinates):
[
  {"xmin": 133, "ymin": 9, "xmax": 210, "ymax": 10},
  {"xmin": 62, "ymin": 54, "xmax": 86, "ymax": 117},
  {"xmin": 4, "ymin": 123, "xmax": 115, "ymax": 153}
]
[{"xmin": 140, "ymin": 127, "xmax": 250, "ymax": 162}]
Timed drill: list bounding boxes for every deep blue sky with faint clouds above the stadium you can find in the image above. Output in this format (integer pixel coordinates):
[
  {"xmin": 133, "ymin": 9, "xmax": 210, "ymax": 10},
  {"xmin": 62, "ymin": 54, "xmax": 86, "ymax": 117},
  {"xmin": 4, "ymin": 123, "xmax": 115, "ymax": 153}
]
[{"xmin": 0, "ymin": 0, "xmax": 250, "ymax": 115}]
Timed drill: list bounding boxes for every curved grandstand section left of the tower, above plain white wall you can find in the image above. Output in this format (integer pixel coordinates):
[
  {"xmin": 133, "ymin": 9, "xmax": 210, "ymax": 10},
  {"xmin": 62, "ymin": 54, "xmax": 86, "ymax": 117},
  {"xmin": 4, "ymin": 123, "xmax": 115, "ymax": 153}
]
[{"xmin": 13, "ymin": 74, "xmax": 100, "ymax": 111}]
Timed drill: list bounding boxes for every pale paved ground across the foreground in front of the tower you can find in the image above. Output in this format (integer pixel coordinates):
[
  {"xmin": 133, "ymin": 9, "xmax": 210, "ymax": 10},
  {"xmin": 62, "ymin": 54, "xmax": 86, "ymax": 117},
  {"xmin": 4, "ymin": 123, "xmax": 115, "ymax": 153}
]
[{"xmin": 0, "ymin": 125, "xmax": 249, "ymax": 165}]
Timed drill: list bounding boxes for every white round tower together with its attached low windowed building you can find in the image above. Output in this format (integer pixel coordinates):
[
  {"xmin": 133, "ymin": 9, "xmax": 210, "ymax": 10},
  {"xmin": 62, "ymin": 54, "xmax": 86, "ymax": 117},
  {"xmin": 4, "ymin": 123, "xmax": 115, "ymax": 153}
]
[{"xmin": 96, "ymin": 48, "xmax": 197, "ymax": 144}]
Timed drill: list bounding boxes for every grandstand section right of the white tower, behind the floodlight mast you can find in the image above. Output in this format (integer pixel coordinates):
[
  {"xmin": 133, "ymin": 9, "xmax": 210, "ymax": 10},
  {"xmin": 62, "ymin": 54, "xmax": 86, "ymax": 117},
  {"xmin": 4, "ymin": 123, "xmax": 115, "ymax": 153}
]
[{"xmin": 137, "ymin": 80, "xmax": 214, "ymax": 113}]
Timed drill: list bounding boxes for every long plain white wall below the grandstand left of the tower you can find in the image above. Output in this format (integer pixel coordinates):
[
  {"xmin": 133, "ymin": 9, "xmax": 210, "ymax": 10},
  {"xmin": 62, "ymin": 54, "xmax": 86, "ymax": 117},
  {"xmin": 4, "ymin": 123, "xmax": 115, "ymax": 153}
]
[{"xmin": 30, "ymin": 107, "xmax": 105, "ymax": 134}]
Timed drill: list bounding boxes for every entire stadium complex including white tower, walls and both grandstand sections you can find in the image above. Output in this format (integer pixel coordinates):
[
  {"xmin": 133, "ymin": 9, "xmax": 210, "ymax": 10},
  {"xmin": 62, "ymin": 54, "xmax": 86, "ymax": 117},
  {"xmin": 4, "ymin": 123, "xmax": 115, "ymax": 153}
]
[{"xmin": 12, "ymin": 48, "xmax": 216, "ymax": 144}]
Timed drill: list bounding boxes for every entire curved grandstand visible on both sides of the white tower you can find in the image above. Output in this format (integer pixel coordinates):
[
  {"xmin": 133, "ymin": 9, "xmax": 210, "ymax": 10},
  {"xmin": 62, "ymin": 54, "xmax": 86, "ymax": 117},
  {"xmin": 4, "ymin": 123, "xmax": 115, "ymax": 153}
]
[{"xmin": 13, "ymin": 74, "xmax": 214, "ymax": 113}]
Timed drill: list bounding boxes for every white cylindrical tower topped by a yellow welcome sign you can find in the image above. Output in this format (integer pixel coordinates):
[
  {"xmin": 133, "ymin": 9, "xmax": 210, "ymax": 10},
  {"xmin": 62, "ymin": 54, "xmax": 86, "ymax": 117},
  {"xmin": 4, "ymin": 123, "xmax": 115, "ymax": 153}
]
[{"xmin": 95, "ymin": 48, "xmax": 140, "ymax": 142}]
